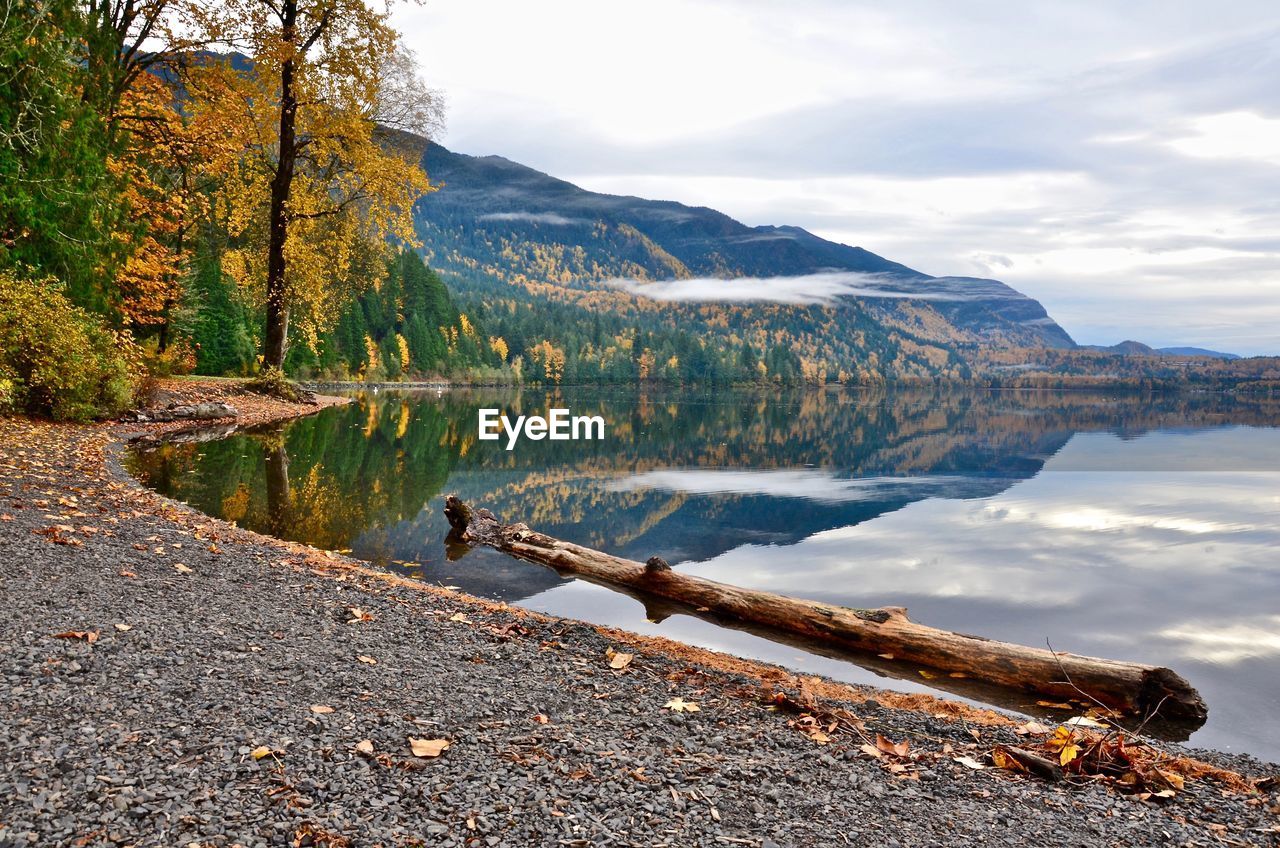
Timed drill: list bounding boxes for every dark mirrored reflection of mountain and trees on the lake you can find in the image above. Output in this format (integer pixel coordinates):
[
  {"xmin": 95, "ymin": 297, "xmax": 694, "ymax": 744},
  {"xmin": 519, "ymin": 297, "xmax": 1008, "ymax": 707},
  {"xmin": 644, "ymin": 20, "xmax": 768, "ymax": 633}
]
[{"xmin": 127, "ymin": 389, "xmax": 1275, "ymax": 601}]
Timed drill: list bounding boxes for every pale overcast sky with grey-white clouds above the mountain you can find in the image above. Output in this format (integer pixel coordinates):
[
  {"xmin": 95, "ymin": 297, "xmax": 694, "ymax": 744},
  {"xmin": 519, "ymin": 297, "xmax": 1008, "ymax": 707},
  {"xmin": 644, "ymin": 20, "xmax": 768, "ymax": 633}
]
[{"xmin": 394, "ymin": 0, "xmax": 1280, "ymax": 355}]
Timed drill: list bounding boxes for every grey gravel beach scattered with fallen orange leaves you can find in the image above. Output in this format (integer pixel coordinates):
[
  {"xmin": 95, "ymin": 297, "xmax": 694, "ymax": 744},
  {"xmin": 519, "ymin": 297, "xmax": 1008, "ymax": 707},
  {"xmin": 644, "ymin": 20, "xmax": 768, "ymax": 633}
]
[{"xmin": 0, "ymin": 380, "xmax": 1280, "ymax": 848}]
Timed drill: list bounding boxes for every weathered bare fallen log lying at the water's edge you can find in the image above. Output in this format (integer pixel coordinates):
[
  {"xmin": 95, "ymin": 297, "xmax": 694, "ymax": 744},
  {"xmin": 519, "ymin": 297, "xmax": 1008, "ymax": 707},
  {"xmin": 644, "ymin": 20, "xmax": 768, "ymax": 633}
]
[{"xmin": 444, "ymin": 494, "xmax": 1208, "ymax": 724}]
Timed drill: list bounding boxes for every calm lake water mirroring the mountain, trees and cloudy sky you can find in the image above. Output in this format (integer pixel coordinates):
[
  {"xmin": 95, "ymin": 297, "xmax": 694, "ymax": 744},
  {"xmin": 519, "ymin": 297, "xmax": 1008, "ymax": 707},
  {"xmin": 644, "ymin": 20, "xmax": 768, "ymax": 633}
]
[{"xmin": 122, "ymin": 388, "xmax": 1280, "ymax": 760}]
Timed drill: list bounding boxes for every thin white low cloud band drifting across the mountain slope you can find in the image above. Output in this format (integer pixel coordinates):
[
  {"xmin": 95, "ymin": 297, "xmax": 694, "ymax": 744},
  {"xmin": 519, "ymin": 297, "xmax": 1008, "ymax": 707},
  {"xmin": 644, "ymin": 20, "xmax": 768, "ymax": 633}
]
[{"xmin": 605, "ymin": 272, "xmax": 1024, "ymax": 305}]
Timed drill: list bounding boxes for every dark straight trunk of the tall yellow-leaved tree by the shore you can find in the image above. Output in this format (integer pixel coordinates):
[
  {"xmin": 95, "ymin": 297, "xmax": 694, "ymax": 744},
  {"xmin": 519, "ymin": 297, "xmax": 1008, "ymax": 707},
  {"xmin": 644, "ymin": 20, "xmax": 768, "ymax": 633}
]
[{"xmin": 262, "ymin": 0, "xmax": 298, "ymax": 370}]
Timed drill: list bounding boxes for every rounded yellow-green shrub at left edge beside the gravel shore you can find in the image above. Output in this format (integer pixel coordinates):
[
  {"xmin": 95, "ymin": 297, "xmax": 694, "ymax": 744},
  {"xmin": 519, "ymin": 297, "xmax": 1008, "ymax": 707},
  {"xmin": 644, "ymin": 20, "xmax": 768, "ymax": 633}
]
[{"xmin": 0, "ymin": 270, "xmax": 143, "ymax": 421}]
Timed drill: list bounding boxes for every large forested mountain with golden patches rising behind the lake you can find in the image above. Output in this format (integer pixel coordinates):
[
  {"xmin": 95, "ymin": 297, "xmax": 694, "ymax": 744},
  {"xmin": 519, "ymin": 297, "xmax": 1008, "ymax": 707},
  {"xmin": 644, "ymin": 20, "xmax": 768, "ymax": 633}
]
[{"xmin": 404, "ymin": 143, "xmax": 1075, "ymax": 382}]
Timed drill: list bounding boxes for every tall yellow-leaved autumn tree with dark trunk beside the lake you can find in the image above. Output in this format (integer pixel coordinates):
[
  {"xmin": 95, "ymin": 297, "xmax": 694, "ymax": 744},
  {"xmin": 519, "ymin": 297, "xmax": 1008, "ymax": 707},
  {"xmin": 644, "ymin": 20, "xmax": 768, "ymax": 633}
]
[{"xmin": 201, "ymin": 0, "xmax": 439, "ymax": 368}]
